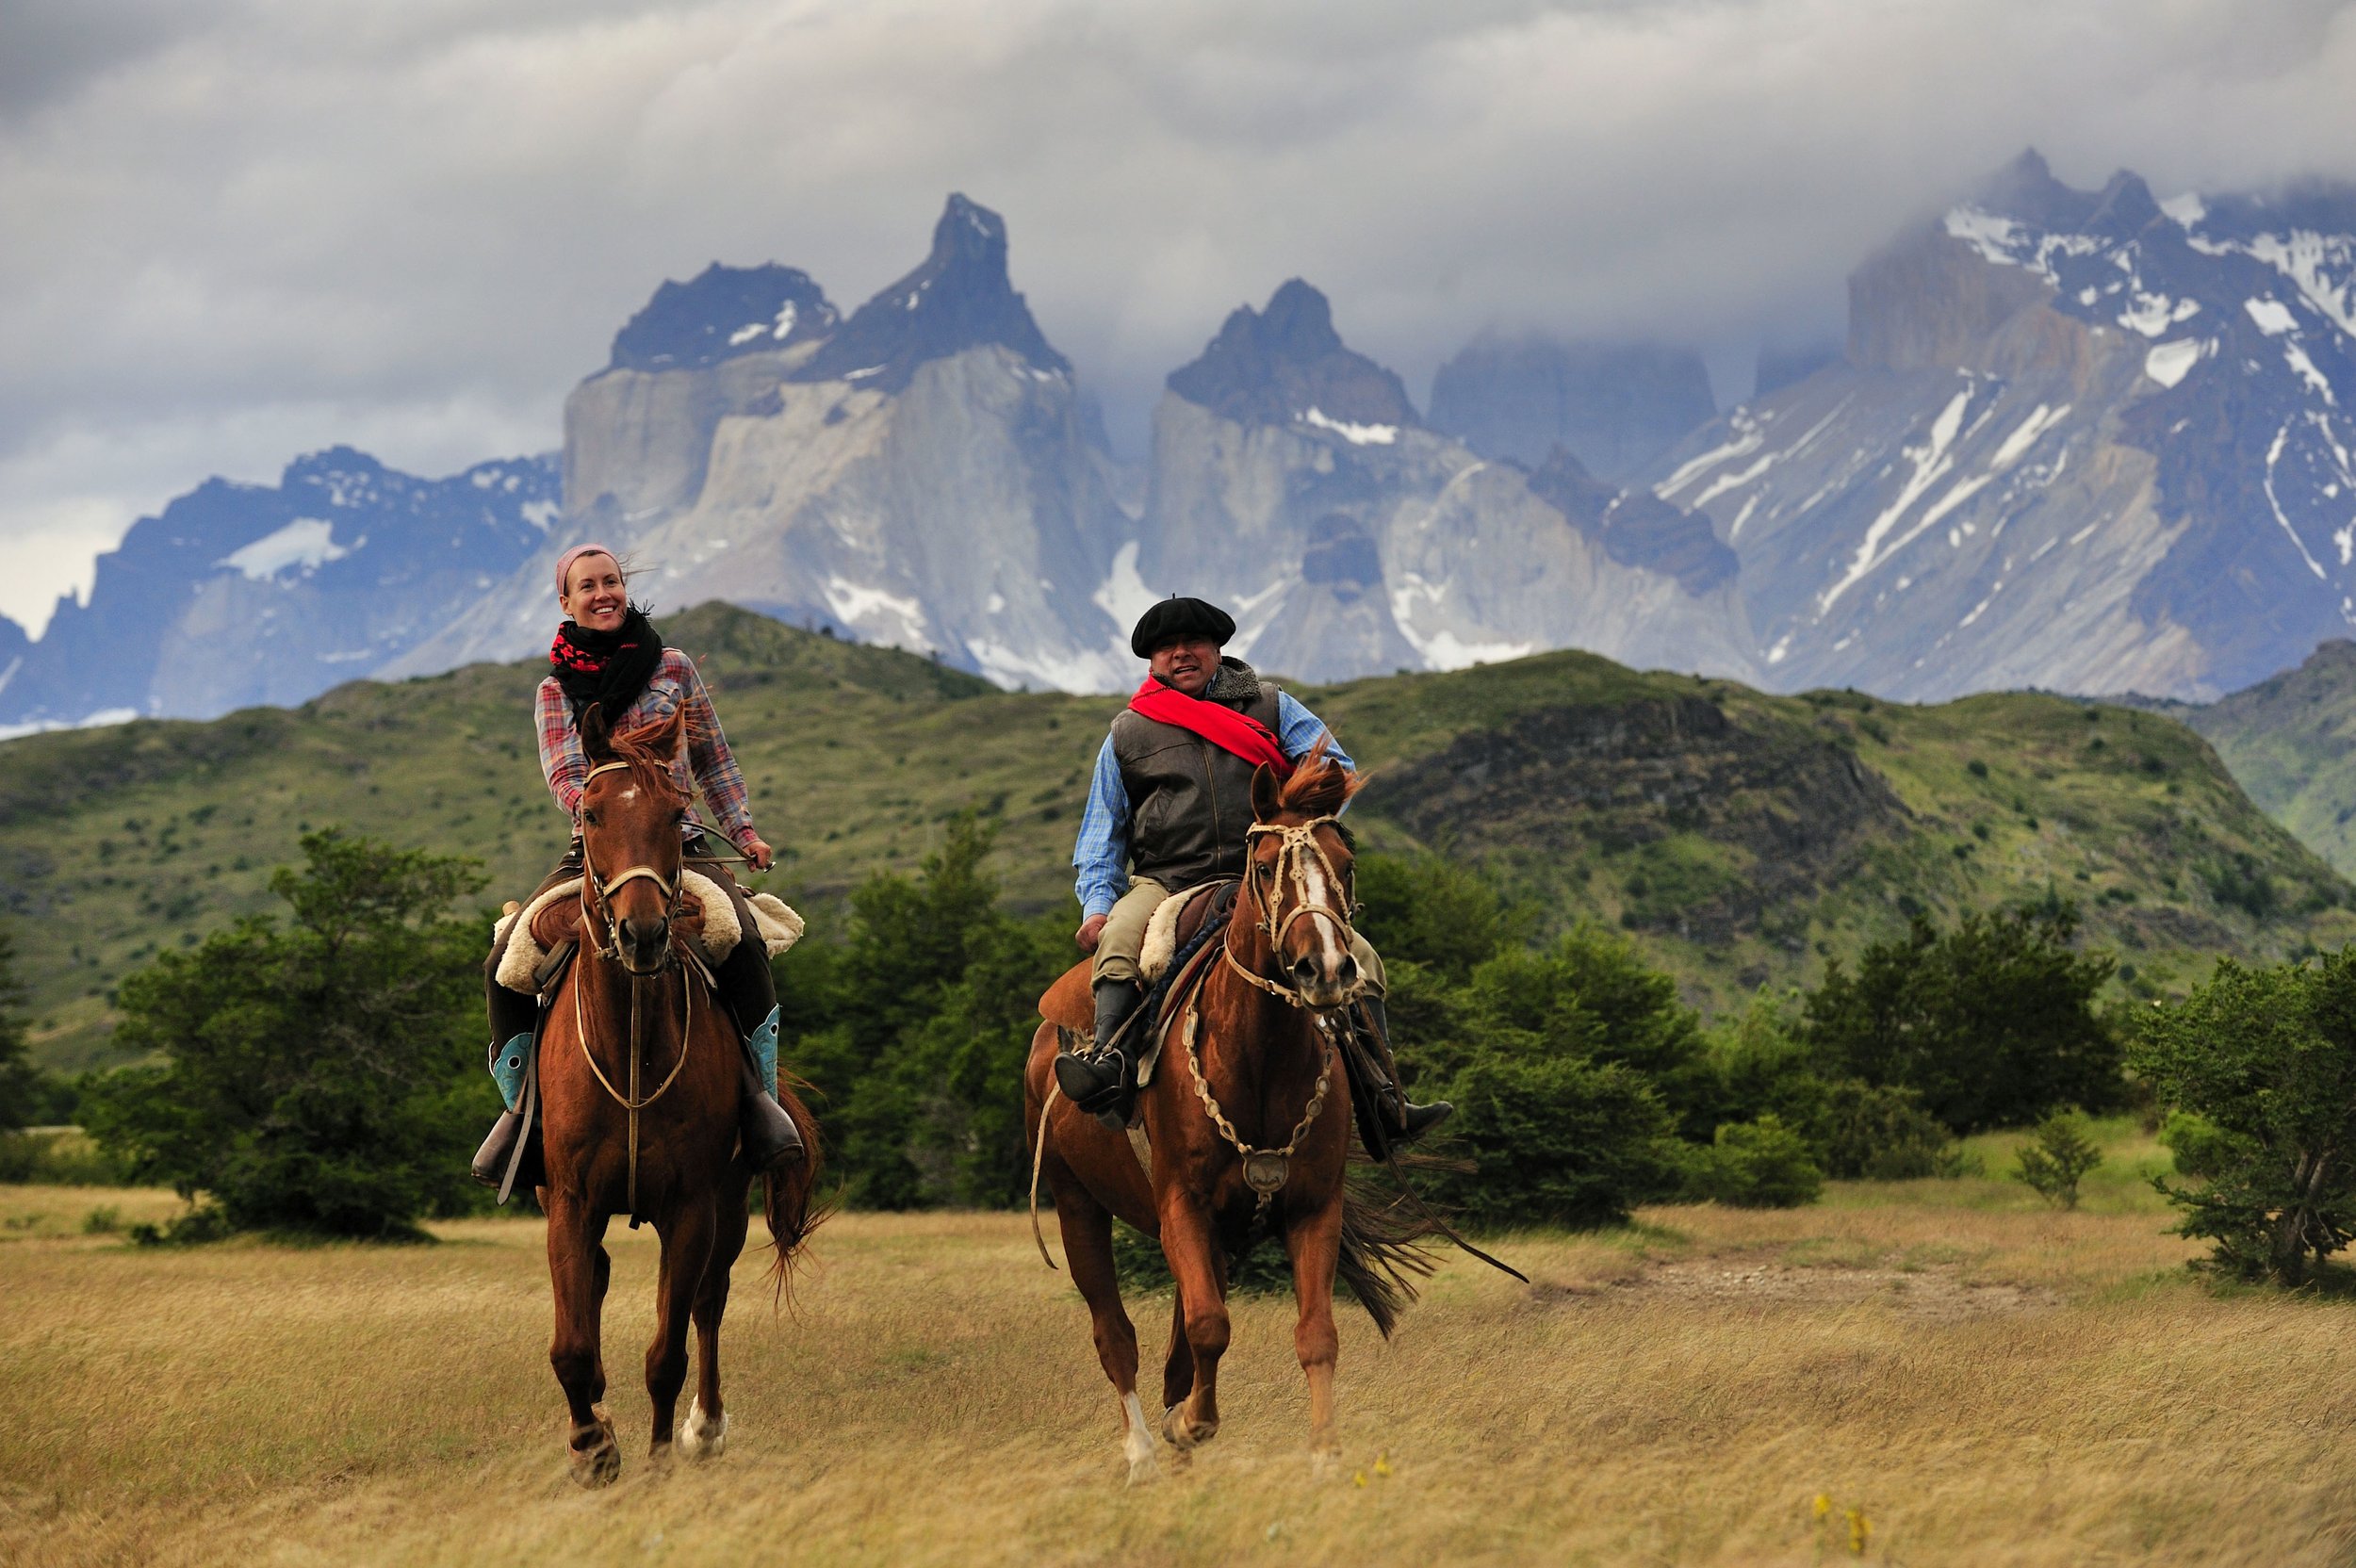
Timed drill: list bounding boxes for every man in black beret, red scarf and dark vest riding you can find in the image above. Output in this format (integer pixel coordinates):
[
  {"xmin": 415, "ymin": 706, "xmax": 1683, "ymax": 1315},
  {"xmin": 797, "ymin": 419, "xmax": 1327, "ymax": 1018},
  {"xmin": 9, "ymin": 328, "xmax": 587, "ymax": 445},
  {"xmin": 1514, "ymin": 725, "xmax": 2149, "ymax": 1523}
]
[{"xmin": 1055, "ymin": 598, "xmax": 1451, "ymax": 1144}]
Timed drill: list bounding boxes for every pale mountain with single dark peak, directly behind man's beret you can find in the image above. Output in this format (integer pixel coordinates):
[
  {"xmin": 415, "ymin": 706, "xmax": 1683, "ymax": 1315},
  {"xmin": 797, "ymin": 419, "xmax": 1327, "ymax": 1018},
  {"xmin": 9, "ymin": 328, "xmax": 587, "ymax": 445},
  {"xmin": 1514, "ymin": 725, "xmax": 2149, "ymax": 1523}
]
[{"xmin": 1131, "ymin": 278, "xmax": 1751, "ymax": 680}]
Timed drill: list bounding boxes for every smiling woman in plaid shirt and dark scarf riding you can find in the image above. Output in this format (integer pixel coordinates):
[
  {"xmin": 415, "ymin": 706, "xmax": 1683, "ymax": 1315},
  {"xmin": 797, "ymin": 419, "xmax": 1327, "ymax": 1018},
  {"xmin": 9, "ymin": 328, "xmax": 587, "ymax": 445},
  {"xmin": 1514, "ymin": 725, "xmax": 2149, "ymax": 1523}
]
[{"xmin": 474, "ymin": 544, "xmax": 804, "ymax": 1186}]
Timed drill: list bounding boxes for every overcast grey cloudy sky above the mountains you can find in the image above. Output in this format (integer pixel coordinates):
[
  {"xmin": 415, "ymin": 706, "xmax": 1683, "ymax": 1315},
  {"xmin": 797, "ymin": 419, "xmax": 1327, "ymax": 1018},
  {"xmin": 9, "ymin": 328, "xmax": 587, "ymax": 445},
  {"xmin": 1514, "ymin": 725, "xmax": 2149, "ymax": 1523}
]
[{"xmin": 0, "ymin": 0, "xmax": 2356, "ymax": 627}]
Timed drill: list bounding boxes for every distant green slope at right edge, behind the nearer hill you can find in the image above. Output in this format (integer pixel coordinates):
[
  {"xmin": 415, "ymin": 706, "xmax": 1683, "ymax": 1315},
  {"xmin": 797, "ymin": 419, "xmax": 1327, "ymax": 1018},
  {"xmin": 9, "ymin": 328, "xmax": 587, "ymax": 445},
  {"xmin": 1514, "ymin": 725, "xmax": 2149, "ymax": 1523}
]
[{"xmin": 2153, "ymin": 643, "xmax": 2356, "ymax": 874}]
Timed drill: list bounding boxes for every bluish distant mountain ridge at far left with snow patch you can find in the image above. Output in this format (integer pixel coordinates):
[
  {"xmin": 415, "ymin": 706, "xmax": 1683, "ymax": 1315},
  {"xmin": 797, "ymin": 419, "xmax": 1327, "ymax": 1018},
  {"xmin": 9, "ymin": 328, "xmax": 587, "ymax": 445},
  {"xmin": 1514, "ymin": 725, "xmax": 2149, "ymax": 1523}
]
[{"xmin": 0, "ymin": 448, "xmax": 559, "ymax": 726}]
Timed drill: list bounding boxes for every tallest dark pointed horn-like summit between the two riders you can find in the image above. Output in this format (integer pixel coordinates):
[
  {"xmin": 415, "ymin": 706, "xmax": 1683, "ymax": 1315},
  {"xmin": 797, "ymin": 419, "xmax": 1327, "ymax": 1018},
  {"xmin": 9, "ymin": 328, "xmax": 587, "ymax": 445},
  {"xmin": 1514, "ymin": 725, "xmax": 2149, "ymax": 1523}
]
[{"xmin": 792, "ymin": 195, "xmax": 1072, "ymax": 393}]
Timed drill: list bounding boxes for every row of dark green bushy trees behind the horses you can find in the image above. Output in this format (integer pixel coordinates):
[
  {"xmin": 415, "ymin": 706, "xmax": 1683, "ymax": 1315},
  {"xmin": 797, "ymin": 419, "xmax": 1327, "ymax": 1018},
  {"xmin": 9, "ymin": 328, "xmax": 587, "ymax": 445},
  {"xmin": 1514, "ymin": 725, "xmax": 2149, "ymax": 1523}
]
[{"xmin": 13, "ymin": 817, "xmax": 2356, "ymax": 1283}]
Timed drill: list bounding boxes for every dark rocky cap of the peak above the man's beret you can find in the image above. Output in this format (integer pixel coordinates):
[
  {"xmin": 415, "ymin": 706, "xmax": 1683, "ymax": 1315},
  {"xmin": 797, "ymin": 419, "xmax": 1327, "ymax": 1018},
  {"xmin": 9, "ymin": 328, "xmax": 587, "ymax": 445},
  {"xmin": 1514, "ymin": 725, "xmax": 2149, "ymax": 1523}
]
[{"xmin": 1169, "ymin": 278, "xmax": 1421, "ymax": 428}]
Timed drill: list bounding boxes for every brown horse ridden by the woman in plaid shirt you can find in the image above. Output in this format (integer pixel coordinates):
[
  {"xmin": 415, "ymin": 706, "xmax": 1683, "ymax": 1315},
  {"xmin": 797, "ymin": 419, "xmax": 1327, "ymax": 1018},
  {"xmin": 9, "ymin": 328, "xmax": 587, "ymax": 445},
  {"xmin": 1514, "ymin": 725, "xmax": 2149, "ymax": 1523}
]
[{"xmin": 540, "ymin": 709, "xmax": 818, "ymax": 1486}]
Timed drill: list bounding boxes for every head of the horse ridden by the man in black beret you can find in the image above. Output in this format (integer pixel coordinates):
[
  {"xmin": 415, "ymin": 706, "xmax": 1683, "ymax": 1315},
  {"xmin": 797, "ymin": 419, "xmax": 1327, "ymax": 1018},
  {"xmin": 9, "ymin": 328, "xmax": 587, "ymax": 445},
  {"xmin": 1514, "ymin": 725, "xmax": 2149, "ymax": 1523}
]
[{"xmin": 1237, "ymin": 742, "xmax": 1365, "ymax": 1010}]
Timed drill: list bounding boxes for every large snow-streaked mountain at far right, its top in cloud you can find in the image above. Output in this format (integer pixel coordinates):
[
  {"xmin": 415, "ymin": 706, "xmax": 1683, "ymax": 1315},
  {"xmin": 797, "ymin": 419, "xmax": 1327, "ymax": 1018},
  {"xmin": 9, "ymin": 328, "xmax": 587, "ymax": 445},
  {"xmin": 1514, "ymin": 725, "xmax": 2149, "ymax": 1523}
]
[{"xmin": 1644, "ymin": 153, "xmax": 2356, "ymax": 699}]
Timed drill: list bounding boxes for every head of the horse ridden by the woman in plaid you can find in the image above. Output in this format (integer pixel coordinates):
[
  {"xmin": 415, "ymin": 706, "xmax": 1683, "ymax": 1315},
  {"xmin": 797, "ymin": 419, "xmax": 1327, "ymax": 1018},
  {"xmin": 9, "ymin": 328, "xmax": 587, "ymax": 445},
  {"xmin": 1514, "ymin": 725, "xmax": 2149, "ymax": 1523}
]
[{"xmin": 580, "ymin": 704, "xmax": 688, "ymax": 974}]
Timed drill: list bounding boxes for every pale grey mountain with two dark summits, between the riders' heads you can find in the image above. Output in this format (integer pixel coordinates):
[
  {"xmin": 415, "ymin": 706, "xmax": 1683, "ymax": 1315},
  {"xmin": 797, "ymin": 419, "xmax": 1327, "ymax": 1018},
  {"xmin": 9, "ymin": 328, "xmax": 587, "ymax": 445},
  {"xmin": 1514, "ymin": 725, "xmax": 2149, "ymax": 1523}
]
[{"xmin": 396, "ymin": 195, "xmax": 1134, "ymax": 690}]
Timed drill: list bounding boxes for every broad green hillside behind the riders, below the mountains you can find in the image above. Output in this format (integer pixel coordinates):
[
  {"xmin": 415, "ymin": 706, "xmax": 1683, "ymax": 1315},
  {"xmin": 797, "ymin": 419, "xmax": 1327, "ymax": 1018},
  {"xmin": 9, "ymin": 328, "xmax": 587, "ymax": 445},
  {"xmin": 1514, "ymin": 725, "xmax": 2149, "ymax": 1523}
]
[{"xmin": 0, "ymin": 605, "xmax": 2356, "ymax": 1069}]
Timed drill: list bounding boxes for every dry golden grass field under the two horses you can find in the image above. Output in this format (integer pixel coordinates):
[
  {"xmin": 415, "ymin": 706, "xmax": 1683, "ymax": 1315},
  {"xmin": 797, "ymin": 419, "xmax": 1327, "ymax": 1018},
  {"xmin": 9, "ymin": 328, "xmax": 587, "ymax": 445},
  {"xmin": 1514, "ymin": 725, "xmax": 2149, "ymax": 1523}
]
[{"xmin": 0, "ymin": 1125, "xmax": 2356, "ymax": 1566}]
